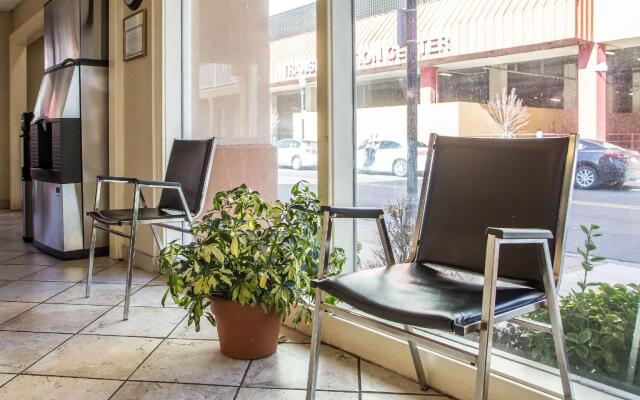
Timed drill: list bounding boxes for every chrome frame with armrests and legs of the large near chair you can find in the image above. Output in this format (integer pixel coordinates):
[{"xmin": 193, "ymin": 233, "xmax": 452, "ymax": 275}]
[{"xmin": 306, "ymin": 134, "xmax": 578, "ymax": 400}]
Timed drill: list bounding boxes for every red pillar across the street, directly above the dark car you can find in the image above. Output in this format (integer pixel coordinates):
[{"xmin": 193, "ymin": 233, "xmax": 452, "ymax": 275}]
[{"xmin": 566, "ymin": 42, "xmax": 607, "ymax": 141}]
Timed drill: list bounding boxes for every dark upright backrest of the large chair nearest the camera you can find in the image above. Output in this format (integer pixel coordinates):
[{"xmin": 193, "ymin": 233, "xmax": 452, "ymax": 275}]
[{"xmin": 414, "ymin": 135, "xmax": 576, "ymax": 288}]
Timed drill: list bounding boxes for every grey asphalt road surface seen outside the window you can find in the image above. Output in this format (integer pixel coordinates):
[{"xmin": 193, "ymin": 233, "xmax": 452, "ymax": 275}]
[{"xmin": 278, "ymin": 169, "xmax": 640, "ymax": 267}]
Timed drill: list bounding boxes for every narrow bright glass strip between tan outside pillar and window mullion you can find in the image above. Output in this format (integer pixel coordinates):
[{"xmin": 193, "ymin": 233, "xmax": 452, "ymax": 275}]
[{"xmin": 269, "ymin": 0, "xmax": 318, "ymax": 199}]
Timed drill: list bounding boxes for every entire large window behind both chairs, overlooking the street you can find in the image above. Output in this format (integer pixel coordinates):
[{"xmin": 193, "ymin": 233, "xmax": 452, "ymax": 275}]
[{"xmin": 182, "ymin": 0, "xmax": 640, "ymax": 395}]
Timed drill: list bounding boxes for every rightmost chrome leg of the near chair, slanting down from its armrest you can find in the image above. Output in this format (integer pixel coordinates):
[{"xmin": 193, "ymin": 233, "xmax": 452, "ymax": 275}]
[{"xmin": 542, "ymin": 243, "xmax": 574, "ymax": 400}]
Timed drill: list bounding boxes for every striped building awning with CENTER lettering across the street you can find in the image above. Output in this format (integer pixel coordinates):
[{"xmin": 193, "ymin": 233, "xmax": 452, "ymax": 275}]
[{"xmin": 270, "ymin": 0, "xmax": 594, "ymax": 83}]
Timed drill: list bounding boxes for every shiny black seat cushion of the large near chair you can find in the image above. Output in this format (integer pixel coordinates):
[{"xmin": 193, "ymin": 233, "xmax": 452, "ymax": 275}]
[{"xmin": 313, "ymin": 263, "xmax": 546, "ymax": 334}]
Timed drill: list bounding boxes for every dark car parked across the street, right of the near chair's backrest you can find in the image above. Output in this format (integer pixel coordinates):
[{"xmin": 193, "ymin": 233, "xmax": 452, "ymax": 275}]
[{"xmin": 575, "ymin": 139, "xmax": 640, "ymax": 189}]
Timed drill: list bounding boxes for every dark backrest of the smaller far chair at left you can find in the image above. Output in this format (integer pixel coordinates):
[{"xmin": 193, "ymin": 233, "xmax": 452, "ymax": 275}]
[{"xmin": 158, "ymin": 138, "xmax": 216, "ymax": 215}]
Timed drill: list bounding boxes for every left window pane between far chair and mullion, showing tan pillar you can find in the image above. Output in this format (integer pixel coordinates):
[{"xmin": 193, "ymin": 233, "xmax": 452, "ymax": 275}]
[{"xmin": 183, "ymin": 0, "xmax": 317, "ymax": 202}]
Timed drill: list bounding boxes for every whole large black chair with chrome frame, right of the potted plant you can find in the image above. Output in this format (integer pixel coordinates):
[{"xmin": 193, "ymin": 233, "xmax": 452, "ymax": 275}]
[{"xmin": 307, "ymin": 134, "xmax": 577, "ymax": 400}]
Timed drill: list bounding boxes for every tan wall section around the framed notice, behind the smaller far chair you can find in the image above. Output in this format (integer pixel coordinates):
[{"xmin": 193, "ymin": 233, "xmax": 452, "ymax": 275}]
[{"xmin": 109, "ymin": 0, "xmax": 163, "ymax": 269}]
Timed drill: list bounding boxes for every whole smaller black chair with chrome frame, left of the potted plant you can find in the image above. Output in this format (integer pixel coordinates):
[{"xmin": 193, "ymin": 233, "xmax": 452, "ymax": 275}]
[{"xmin": 86, "ymin": 138, "xmax": 216, "ymax": 320}]
